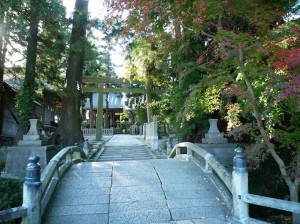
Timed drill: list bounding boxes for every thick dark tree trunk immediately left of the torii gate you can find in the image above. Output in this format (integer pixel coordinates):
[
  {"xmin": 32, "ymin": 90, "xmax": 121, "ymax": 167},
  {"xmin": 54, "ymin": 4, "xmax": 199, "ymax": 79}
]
[{"xmin": 54, "ymin": 0, "xmax": 88, "ymax": 146}]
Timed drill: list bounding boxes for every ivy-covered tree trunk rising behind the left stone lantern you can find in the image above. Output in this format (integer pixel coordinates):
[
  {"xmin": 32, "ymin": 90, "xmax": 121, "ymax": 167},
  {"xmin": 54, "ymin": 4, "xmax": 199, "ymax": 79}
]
[{"xmin": 17, "ymin": 0, "xmax": 40, "ymax": 134}]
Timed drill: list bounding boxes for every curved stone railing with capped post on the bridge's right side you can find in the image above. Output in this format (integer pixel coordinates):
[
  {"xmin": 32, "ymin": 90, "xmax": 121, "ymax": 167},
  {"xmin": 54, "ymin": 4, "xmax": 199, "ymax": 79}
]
[{"xmin": 169, "ymin": 142, "xmax": 300, "ymax": 223}]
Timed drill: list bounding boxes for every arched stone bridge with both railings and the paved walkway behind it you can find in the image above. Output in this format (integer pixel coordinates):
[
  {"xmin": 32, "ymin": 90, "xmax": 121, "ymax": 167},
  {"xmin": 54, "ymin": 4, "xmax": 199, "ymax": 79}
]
[{"xmin": 0, "ymin": 135, "xmax": 300, "ymax": 224}]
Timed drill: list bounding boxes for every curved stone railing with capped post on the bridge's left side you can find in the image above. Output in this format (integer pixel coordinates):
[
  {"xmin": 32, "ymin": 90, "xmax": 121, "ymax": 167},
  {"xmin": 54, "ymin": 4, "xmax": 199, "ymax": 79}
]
[{"xmin": 0, "ymin": 146, "xmax": 87, "ymax": 224}]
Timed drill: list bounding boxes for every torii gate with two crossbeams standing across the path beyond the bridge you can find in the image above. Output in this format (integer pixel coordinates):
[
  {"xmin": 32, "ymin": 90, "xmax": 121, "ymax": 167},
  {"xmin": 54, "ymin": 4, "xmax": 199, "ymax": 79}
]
[{"xmin": 82, "ymin": 75, "xmax": 163, "ymax": 141}]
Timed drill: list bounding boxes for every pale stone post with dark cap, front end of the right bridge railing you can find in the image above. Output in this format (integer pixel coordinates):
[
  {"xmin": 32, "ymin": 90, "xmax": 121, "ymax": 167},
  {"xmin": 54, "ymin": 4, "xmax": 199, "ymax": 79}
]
[{"xmin": 232, "ymin": 147, "xmax": 249, "ymax": 221}]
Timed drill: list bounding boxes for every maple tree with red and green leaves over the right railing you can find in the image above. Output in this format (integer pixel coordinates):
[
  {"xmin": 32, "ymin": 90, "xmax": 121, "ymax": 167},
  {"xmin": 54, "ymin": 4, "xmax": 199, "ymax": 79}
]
[{"xmin": 111, "ymin": 0, "xmax": 300, "ymax": 223}]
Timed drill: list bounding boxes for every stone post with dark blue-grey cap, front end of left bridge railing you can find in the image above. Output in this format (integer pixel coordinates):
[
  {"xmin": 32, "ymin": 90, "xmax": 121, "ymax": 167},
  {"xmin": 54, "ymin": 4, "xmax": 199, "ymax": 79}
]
[{"xmin": 22, "ymin": 154, "xmax": 42, "ymax": 224}]
